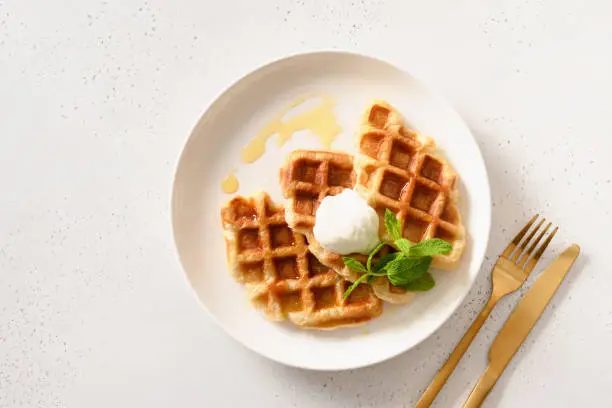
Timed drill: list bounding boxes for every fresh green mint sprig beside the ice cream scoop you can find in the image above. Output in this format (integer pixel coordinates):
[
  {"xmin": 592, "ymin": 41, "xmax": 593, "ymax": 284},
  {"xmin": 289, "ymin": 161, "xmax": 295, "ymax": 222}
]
[{"xmin": 343, "ymin": 209, "xmax": 453, "ymax": 299}]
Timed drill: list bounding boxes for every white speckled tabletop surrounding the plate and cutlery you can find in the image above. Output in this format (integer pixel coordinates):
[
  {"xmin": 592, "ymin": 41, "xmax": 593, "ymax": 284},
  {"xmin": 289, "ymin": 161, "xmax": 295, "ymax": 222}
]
[{"xmin": 0, "ymin": 0, "xmax": 612, "ymax": 408}]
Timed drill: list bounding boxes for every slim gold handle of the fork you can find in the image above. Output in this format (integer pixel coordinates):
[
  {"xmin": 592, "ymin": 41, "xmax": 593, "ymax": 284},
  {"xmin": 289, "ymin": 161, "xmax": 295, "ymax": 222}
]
[{"xmin": 415, "ymin": 296, "xmax": 499, "ymax": 408}]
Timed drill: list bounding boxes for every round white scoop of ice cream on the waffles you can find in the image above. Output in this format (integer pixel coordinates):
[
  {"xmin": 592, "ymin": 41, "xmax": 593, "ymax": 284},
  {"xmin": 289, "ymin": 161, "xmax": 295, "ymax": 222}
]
[{"xmin": 314, "ymin": 189, "xmax": 380, "ymax": 255}]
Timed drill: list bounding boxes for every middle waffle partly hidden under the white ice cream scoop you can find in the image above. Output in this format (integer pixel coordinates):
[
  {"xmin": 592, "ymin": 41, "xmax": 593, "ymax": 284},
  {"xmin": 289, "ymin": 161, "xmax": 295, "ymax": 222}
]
[{"xmin": 280, "ymin": 150, "xmax": 413, "ymax": 303}]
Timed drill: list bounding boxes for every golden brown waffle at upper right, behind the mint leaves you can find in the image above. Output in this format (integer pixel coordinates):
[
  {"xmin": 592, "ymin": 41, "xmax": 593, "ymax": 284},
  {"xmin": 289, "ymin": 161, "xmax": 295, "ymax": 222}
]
[{"xmin": 355, "ymin": 101, "xmax": 465, "ymax": 270}]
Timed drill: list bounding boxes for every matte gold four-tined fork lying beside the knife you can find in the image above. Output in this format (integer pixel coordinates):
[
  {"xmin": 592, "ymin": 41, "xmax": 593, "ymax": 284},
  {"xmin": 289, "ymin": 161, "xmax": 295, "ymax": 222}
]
[{"xmin": 415, "ymin": 215, "xmax": 559, "ymax": 408}]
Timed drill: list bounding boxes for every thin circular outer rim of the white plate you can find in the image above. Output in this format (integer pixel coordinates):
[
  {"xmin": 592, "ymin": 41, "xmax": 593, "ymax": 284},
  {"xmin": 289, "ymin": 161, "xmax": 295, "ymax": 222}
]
[{"xmin": 170, "ymin": 49, "xmax": 492, "ymax": 371}]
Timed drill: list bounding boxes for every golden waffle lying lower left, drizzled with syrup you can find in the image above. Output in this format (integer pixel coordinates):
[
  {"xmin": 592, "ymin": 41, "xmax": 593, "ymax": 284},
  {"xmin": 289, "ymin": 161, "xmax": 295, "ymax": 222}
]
[{"xmin": 221, "ymin": 193, "xmax": 382, "ymax": 329}]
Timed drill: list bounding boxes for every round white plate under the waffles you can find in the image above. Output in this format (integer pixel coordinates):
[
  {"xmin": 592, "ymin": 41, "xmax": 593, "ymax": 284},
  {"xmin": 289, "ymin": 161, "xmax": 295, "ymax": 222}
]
[{"xmin": 172, "ymin": 52, "xmax": 491, "ymax": 370}]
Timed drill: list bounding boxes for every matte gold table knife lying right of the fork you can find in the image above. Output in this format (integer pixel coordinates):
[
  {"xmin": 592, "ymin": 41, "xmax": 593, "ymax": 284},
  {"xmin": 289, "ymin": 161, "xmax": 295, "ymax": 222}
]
[{"xmin": 463, "ymin": 244, "xmax": 580, "ymax": 408}]
